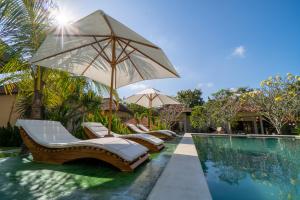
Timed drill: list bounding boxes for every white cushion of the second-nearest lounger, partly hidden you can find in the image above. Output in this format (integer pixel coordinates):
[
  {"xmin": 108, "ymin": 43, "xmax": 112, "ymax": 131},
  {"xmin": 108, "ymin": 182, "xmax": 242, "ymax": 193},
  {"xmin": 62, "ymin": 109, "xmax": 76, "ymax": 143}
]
[{"xmin": 82, "ymin": 122, "xmax": 164, "ymax": 145}]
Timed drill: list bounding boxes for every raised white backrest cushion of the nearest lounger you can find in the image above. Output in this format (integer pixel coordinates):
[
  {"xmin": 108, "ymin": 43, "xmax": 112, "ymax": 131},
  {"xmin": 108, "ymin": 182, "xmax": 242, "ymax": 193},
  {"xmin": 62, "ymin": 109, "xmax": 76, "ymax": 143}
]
[{"xmin": 16, "ymin": 119, "xmax": 80, "ymax": 147}]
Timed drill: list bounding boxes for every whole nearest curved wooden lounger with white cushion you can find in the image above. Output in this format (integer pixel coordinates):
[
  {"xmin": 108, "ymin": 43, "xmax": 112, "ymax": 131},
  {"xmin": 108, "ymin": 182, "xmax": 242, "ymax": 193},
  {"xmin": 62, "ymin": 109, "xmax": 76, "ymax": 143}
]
[{"xmin": 16, "ymin": 120, "xmax": 149, "ymax": 171}]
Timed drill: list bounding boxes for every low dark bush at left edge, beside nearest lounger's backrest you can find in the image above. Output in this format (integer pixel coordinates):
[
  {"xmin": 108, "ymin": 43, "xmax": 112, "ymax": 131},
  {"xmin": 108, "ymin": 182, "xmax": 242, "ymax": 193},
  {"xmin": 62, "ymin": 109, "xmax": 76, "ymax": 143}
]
[{"xmin": 0, "ymin": 124, "xmax": 22, "ymax": 147}]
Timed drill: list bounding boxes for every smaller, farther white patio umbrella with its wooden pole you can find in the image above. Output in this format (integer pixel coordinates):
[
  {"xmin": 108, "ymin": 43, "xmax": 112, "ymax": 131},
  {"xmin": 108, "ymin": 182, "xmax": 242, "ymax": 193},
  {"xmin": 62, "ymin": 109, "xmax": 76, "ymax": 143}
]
[{"xmin": 125, "ymin": 88, "xmax": 180, "ymax": 129}]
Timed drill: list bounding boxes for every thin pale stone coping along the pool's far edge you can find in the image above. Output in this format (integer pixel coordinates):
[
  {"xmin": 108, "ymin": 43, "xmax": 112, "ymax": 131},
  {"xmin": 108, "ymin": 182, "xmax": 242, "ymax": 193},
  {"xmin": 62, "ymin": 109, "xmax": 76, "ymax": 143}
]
[{"xmin": 190, "ymin": 133, "xmax": 300, "ymax": 140}]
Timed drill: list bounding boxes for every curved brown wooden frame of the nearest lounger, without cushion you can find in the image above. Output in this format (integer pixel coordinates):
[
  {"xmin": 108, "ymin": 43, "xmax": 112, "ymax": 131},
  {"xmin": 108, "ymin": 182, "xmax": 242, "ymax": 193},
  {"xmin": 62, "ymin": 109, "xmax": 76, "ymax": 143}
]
[{"xmin": 20, "ymin": 128, "xmax": 149, "ymax": 172}]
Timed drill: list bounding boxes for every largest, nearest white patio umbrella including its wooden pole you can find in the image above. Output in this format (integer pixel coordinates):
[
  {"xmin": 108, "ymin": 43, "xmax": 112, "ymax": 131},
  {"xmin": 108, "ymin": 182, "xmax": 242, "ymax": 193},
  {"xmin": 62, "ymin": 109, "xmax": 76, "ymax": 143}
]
[{"xmin": 31, "ymin": 11, "xmax": 179, "ymax": 134}]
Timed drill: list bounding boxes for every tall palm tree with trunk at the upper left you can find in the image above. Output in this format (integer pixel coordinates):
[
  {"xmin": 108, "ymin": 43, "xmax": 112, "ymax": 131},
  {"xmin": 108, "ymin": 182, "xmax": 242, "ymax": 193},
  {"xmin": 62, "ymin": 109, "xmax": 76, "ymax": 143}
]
[{"xmin": 0, "ymin": 0, "xmax": 57, "ymax": 119}]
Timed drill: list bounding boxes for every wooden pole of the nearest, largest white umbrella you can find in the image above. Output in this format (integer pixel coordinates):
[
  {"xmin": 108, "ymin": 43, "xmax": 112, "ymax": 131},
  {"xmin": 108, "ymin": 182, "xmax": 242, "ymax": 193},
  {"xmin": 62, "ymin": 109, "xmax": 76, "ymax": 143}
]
[{"xmin": 108, "ymin": 37, "xmax": 116, "ymax": 136}]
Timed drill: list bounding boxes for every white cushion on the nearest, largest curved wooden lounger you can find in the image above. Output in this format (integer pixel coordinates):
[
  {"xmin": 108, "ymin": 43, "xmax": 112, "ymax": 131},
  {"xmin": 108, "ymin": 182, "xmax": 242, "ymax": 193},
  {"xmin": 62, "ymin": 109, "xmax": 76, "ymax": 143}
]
[{"xmin": 16, "ymin": 120, "xmax": 148, "ymax": 162}]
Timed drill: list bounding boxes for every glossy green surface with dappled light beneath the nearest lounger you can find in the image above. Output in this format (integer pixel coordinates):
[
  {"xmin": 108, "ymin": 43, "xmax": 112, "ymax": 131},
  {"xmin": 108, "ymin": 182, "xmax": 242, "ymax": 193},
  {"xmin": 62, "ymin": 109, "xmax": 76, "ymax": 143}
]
[{"xmin": 0, "ymin": 139, "xmax": 179, "ymax": 200}]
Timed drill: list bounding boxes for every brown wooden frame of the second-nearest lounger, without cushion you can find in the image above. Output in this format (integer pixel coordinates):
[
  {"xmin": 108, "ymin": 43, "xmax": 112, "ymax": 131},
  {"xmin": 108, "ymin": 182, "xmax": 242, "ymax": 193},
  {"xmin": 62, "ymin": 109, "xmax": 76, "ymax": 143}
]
[{"xmin": 83, "ymin": 127, "xmax": 165, "ymax": 153}]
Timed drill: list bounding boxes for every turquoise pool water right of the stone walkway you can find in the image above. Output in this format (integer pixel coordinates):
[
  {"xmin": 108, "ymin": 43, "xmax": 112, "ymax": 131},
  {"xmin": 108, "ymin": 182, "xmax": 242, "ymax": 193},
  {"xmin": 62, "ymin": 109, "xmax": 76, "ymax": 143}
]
[{"xmin": 194, "ymin": 136, "xmax": 300, "ymax": 200}]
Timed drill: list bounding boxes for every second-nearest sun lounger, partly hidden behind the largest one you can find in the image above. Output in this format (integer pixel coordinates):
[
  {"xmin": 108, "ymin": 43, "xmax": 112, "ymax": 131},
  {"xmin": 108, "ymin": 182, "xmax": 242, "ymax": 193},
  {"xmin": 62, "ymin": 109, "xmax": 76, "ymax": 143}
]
[{"xmin": 82, "ymin": 122, "xmax": 164, "ymax": 152}]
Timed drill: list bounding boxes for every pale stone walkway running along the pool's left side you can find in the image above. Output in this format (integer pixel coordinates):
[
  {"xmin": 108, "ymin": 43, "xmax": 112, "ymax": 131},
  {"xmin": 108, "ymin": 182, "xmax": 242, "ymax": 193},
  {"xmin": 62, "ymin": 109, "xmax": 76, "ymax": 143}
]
[{"xmin": 147, "ymin": 133, "xmax": 212, "ymax": 200}]
